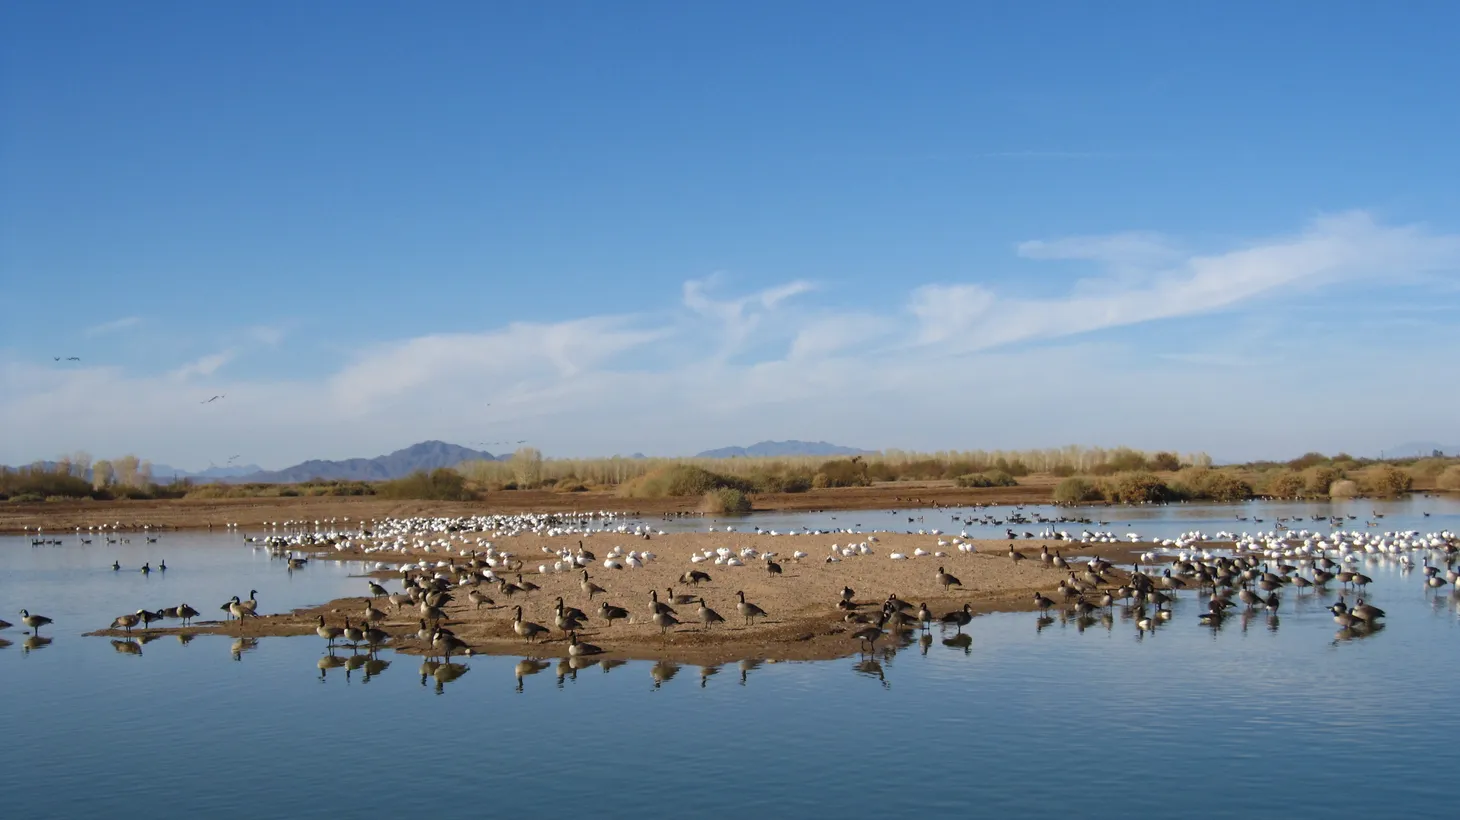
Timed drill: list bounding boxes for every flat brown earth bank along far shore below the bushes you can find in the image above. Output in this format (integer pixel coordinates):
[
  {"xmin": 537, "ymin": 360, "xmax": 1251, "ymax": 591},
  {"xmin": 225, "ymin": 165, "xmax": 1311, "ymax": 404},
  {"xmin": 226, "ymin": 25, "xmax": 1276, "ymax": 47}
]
[{"xmin": 0, "ymin": 477, "xmax": 1057, "ymax": 533}]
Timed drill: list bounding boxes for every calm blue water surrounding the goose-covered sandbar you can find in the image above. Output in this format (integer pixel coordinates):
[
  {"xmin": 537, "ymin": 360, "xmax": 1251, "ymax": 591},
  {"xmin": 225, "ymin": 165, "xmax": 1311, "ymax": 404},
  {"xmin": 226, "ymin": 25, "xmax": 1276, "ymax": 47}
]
[{"xmin": 0, "ymin": 499, "xmax": 1460, "ymax": 819}]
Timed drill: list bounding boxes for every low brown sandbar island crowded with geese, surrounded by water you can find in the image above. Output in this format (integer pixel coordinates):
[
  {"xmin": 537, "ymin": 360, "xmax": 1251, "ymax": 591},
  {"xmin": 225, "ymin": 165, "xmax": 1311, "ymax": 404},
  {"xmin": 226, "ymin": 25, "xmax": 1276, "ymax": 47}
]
[{"xmin": 89, "ymin": 533, "xmax": 1149, "ymax": 664}]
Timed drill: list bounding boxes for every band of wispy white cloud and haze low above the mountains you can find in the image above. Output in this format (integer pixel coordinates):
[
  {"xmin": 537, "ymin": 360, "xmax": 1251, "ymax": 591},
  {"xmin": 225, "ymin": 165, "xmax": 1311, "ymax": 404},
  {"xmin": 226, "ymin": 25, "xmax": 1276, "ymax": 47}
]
[{"xmin": 0, "ymin": 213, "xmax": 1460, "ymax": 465}]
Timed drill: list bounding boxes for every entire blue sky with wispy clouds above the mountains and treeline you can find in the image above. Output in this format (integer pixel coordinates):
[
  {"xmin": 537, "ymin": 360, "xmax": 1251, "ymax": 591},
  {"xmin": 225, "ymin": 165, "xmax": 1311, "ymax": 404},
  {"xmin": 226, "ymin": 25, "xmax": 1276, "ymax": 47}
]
[{"xmin": 0, "ymin": 1, "xmax": 1460, "ymax": 467}]
